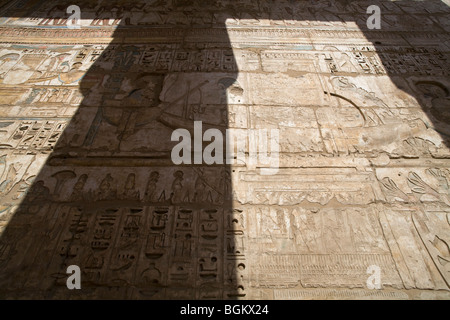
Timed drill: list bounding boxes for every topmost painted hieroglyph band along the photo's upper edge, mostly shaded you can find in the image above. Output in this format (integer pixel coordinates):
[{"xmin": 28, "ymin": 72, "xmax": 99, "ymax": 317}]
[{"xmin": 1, "ymin": 0, "xmax": 448, "ymax": 30}]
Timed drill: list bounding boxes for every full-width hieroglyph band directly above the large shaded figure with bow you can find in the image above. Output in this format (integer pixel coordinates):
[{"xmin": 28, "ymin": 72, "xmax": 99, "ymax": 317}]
[{"xmin": 0, "ymin": 44, "xmax": 448, "ymax": 82}]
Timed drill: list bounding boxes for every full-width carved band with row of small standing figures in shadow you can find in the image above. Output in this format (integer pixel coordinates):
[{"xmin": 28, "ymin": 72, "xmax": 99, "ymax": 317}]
[{"xmin": 0, "ymin": 155, "xmax": 450, "ymax": 210}]
